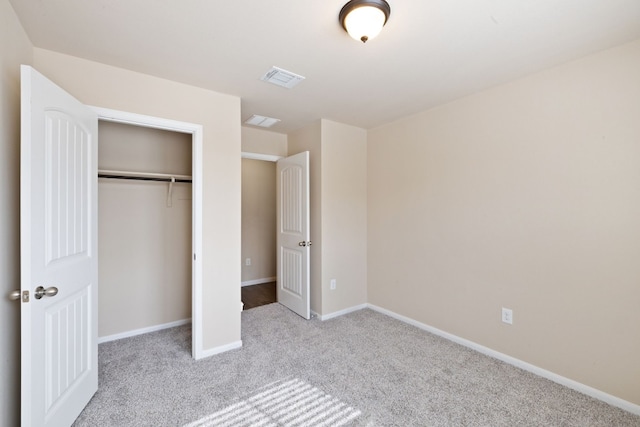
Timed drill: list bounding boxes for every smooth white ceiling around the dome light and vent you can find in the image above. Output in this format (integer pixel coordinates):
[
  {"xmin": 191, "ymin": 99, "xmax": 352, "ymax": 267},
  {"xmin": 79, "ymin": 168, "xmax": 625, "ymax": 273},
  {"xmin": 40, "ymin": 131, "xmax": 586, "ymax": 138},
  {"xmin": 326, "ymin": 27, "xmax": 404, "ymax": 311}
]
[{"xmin": 10, "ymin": 0, "xmax": 640, "ymax": 133}]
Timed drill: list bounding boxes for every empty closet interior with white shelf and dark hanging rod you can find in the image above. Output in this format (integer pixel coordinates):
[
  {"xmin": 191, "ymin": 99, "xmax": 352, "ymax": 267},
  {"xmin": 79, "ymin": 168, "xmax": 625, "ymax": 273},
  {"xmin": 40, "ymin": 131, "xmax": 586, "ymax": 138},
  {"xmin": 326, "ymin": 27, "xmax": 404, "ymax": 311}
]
[{"xmin": 98, "ymin": 121, "xmax": 193, "ymax": 341}]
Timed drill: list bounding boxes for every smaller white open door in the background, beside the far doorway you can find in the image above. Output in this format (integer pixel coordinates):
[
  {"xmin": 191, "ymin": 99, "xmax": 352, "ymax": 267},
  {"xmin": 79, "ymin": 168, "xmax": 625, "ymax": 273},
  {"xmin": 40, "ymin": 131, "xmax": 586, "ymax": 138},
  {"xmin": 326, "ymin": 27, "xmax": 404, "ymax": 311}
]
[{"xmin": 276, "ymin": 151, "xmax": 311, "ymax": 319}]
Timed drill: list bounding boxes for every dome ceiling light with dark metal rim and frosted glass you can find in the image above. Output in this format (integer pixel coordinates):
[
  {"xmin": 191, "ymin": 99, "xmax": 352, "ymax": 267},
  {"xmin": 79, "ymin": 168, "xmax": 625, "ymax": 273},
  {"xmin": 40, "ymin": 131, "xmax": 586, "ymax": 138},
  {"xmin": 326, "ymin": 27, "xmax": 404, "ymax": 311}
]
[{"xmin": 339, "ymin": 0, "xmax": 391, "ymax": 43}]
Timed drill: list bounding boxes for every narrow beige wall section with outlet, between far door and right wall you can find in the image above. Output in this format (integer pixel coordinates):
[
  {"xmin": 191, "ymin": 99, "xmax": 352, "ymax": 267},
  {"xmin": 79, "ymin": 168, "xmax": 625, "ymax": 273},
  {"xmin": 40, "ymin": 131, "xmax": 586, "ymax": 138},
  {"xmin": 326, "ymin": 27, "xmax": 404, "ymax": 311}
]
[{"xmin": 322, "ymin": 120, "xmax": 367, "ymax": 315}]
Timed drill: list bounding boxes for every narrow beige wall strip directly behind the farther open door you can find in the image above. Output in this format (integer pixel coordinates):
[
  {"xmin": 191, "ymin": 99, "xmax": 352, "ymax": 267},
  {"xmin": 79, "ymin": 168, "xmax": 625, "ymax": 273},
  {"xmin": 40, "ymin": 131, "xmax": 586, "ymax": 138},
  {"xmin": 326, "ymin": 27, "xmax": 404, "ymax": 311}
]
[{"xmin": 287, "ymin": 121, "xmax": 322, "ymax": 314}]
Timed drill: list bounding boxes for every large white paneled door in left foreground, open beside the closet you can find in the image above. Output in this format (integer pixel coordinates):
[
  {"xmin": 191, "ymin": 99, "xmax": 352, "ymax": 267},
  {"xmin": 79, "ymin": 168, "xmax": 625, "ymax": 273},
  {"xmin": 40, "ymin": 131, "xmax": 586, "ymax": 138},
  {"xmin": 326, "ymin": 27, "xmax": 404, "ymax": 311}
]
[{"xmin": 20, "ymin": 65, "xmax": 98, "ymax": 426}]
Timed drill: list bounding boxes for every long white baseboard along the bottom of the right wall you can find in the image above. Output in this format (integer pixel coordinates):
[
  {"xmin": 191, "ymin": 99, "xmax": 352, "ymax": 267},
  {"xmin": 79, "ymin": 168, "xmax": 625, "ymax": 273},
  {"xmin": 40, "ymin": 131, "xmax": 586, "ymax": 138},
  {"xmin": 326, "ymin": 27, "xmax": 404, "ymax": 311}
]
[{"xmin": 367, "ymin": 304, "xmax": 640, "ymax": 415}]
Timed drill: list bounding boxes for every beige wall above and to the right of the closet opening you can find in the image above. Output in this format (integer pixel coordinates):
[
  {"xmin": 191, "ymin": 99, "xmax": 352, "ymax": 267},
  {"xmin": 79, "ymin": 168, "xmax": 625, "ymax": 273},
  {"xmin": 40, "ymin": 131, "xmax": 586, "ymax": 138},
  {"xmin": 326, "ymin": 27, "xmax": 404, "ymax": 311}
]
[{"xmin": 34, "ymin": 49, "xmax": 241, "ymax": 350}]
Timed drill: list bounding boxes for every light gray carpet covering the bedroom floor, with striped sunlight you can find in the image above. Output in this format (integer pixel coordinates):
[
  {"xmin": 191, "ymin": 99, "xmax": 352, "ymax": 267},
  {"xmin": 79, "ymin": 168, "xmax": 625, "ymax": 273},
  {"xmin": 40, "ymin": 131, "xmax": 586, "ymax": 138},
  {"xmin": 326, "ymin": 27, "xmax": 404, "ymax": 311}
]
[{"xmin": 74, "ymin": 304, "xmax": 640, "ymax": 427}]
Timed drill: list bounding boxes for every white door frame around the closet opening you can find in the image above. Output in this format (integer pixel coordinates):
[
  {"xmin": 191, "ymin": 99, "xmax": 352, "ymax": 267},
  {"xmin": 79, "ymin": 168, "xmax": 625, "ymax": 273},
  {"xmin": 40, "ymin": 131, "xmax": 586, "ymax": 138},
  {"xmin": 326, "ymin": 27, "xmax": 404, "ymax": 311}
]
[{"xmin": 88, "ymin": 106, "xmax": 207, "ymax": 360}]
